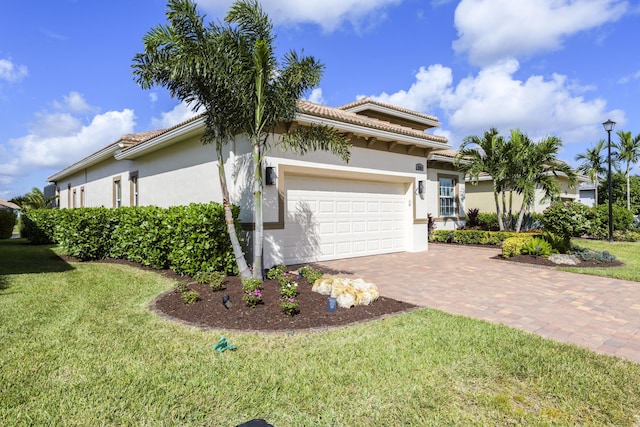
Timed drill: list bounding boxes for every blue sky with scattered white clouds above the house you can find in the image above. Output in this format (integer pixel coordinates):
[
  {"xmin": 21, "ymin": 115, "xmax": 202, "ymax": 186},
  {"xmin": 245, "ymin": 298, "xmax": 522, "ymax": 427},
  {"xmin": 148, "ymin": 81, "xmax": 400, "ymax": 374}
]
[{"xmin": 0, "ymin": 0, "xmax": 640, "ymax": 199}]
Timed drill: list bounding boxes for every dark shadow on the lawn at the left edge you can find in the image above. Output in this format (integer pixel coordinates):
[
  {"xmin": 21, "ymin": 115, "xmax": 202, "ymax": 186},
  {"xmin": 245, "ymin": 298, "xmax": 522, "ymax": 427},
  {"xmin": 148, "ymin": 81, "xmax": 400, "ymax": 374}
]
[{"xmin": 0, "ymin": 239, "xmax": 74, "ymax": 278}]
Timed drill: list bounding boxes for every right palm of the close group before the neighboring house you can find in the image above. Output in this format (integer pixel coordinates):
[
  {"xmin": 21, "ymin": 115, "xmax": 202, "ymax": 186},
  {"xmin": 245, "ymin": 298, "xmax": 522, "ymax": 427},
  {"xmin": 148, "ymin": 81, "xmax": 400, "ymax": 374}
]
[{"xmin": 511, "ymin": 129, "xmax": 576, "ymax": 232}]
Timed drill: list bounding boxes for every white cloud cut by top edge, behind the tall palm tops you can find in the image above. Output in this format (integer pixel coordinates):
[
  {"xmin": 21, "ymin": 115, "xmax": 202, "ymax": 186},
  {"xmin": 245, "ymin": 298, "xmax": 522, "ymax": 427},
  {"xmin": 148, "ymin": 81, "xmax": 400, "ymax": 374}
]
[{"xmin": 198, "ymin": 0, "xmax": 402, "ymax": 32}]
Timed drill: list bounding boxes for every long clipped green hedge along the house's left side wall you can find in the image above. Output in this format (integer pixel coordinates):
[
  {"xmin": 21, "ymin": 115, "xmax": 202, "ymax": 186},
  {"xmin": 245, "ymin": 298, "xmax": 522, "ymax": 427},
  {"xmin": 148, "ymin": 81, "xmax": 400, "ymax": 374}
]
[{"xmin": 23, "ymin": 203, "xmax": 240, "ymax": 275}]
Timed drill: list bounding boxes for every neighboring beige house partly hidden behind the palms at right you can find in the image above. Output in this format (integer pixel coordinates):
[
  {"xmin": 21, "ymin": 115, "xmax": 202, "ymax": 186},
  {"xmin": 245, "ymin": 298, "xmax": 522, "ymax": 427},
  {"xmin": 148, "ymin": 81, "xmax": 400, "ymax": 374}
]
[{"xmin": 466, "ymin": 173, "xmax": 587, "ymax": 214}]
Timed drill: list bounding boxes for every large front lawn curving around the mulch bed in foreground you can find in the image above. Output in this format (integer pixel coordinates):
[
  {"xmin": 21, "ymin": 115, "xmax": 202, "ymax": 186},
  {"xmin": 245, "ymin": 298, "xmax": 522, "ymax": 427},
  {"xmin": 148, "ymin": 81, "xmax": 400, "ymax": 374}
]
[{"xmin": 0, "ymin": 240, "xmax": 640, "ymax": 426}]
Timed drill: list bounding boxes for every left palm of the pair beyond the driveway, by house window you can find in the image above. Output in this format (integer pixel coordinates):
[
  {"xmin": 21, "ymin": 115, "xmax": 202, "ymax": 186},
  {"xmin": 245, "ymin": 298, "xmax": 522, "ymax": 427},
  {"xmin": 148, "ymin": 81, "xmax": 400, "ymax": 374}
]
[{"xmin": 454, "ymin": 128, "xmax": 508, "ymax": 230}]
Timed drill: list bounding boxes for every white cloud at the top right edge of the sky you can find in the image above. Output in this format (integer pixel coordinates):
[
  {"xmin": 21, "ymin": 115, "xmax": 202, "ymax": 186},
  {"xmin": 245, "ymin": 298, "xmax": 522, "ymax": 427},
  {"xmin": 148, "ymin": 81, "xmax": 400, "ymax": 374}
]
[{"xmin": 453, "ymin": 0, "xmax": 628, "ymax": 65}]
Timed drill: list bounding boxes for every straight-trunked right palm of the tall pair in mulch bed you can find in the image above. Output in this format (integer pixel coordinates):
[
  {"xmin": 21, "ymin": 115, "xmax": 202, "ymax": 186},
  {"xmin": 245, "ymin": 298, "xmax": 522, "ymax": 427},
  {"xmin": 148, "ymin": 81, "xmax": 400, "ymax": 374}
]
[{"xmin": 225, "ymin": 0, "xmax": 350, "ymax": 278}]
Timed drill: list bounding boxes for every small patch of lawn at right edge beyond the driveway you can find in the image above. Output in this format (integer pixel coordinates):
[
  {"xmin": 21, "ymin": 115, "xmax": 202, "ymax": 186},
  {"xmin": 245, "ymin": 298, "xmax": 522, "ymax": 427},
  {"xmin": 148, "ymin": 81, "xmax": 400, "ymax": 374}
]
[{"xmin": 559, "ymin": 239, "xmax": 640, "ymax": 282}]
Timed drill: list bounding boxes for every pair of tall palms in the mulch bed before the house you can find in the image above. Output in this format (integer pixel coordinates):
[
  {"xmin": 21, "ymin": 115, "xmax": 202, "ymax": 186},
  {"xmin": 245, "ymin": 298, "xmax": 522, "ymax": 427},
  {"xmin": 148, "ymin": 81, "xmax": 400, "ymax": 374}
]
[{"xmin": 133, "ymin": 0, "xmax": 350, "ymax": 278}]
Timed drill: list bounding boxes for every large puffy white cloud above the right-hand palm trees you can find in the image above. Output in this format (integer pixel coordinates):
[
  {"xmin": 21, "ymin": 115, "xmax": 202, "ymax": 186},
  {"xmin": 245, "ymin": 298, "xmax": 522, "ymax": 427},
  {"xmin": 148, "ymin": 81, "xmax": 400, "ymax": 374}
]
[{"xmin": 374, "ymin": 59, "xmax": 625, "ymax": 145}]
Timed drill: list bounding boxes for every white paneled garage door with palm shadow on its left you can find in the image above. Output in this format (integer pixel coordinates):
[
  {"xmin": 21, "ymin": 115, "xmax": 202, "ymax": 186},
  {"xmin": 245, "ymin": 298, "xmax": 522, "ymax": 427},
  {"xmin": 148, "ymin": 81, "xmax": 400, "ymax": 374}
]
[{"xmin": 283, "ymin": 175, "xmax": 408, "ymax": 264}]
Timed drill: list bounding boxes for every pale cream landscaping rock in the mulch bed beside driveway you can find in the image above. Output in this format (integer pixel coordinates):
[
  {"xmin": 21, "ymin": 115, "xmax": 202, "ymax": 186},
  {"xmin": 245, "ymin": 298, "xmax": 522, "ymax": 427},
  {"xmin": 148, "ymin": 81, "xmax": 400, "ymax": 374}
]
[{"xmin": 312, "ymin": 277, "xmax": 380, "ymax": 308}]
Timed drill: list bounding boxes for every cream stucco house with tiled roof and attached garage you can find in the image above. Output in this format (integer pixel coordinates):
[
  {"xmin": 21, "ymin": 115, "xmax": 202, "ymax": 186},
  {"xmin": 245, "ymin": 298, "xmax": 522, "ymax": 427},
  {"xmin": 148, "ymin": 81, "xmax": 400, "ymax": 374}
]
[{"xmin": 49, "ymin": 98, "xmax": 464, "ymax": 266}]
